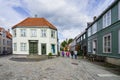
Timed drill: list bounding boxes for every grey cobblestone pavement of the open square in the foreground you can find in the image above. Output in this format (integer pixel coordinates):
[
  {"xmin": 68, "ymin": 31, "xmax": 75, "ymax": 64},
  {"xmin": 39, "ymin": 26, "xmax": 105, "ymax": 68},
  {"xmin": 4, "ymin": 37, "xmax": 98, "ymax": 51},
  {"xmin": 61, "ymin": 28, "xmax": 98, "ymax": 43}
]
[{"xmin": 0, "ymin": 56, "xmax": 120, "ymax": 80}]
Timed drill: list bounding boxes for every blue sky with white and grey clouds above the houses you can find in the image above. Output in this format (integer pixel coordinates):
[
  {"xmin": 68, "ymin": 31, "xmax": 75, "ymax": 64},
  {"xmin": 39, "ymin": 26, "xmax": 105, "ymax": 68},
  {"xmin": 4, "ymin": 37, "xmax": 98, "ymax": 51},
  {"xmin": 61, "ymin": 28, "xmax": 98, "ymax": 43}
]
[{"xmin": 0, "ymin": 0, "xmax": 114, "ymax": 42}]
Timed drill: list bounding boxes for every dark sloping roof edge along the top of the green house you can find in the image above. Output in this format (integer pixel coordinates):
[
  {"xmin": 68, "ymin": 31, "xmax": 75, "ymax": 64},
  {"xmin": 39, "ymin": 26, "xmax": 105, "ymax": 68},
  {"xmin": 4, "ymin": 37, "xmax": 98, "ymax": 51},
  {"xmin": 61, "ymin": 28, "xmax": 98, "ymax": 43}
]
[{"xmin": 86, "ymin": 0, "xmax": 119, "ymax": 30}]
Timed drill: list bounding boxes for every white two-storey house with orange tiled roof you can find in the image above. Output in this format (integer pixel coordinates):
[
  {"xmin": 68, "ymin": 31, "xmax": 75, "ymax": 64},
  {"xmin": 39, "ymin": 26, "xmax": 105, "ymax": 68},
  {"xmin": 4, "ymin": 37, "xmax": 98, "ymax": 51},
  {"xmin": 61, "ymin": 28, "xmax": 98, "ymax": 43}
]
[{"xmin": 12, "ymin": 18, "xmax": 58, "ymax": 55}]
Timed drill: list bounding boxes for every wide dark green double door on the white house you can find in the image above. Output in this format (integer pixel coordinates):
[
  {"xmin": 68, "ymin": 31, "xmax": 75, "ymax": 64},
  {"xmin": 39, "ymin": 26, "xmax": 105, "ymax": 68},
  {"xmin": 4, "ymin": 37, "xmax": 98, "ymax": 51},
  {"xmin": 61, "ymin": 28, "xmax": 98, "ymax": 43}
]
[{"xmin": 29, "ymin": 41, "xmax": 38, "ymax": 54}]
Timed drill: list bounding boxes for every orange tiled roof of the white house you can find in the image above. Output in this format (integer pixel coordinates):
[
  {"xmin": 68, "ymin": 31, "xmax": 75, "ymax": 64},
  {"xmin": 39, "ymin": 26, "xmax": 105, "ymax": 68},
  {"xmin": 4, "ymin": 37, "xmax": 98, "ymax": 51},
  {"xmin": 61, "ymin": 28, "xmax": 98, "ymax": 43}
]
[{"xmin": 12, "ymin": 17, "xmax": 57, "ymax": 30}]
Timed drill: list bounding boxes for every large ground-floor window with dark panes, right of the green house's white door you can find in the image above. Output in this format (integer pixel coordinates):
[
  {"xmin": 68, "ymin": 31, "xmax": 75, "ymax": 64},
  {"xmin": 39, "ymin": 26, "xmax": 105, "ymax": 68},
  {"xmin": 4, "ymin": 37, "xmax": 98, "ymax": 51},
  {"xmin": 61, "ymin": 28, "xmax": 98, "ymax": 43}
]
[{"xmin": 103, "ymin": 33, "xmax": 111, "ymax": 53}]
